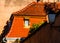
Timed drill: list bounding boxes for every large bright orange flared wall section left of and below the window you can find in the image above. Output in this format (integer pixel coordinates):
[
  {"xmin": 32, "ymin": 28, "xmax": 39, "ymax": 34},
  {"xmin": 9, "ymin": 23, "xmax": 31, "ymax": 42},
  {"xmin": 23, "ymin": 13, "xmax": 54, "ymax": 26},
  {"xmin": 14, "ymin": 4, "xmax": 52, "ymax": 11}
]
[{"xmin": 6, "ymin": 17, "xmax": 29, "ymax": 38}]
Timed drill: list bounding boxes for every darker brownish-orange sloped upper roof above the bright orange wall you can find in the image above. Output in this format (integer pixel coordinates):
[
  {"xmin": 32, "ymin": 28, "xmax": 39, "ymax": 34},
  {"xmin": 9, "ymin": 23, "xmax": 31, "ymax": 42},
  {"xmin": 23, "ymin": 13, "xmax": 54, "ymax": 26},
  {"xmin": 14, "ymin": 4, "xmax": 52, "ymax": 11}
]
[{"xmin": 12, "ymin": 2, "xmax": 46, "ymax": 16}]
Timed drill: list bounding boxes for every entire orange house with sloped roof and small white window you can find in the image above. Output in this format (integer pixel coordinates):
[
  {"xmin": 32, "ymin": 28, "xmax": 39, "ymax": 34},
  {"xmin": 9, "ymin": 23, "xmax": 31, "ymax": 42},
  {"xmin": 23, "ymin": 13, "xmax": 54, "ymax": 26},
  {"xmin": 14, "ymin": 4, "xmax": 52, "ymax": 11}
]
[{"xmin": 5, "ymin": 2, "xmax": 46, "ymax": 43}]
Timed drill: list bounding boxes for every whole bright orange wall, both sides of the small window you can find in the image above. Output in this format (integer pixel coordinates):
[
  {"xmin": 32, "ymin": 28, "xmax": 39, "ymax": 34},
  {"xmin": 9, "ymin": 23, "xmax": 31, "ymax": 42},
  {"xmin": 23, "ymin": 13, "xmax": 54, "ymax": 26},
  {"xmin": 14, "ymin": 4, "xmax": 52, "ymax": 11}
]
[{"xmin": 6, "ymin": 16, "xmax": 45, "ymax": 37}]
